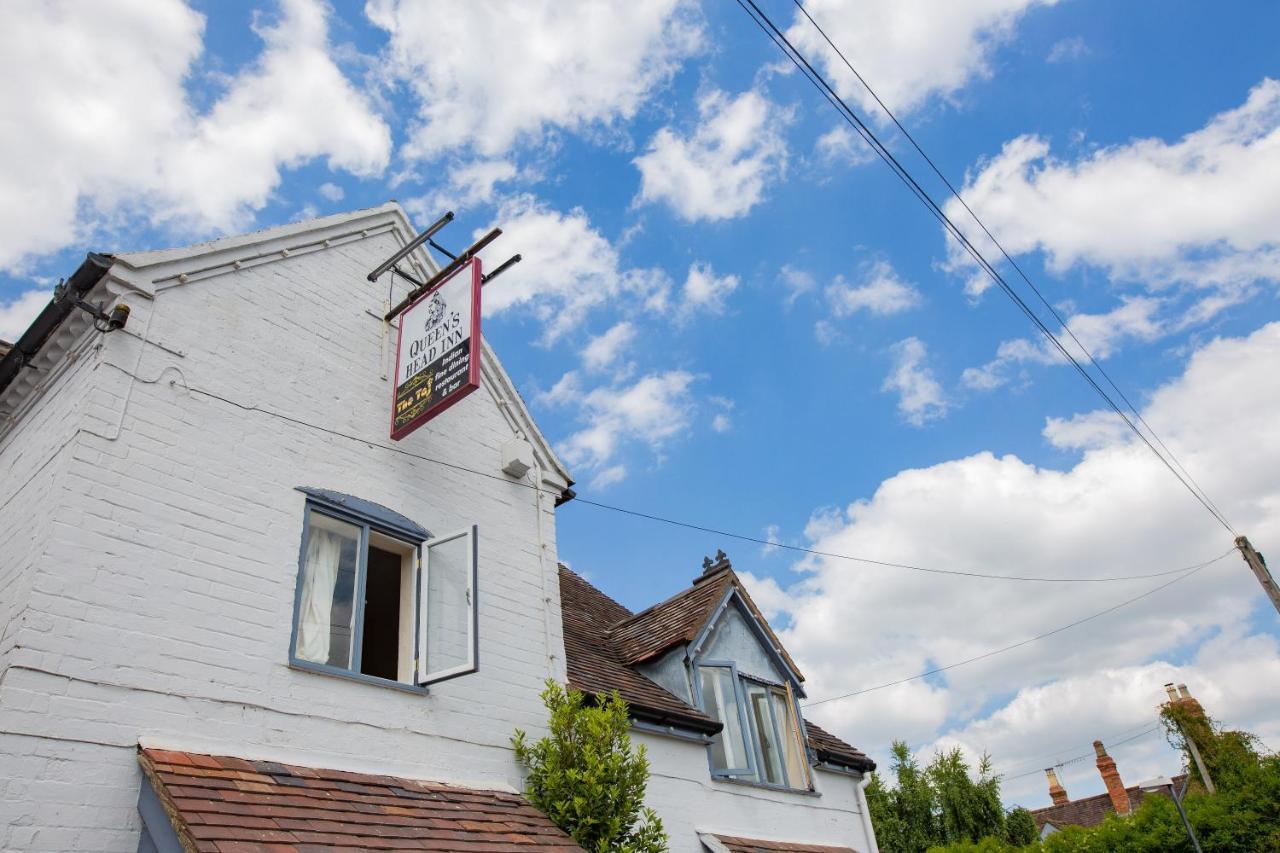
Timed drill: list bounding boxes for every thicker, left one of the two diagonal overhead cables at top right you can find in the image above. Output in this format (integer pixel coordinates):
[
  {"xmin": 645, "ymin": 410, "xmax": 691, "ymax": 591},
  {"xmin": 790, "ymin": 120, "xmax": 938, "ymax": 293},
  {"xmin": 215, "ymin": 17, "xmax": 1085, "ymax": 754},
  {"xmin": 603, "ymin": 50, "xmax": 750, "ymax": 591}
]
[{"xmin": 736, "ymin": 0, "xmax": 1235, "ymax": 534}]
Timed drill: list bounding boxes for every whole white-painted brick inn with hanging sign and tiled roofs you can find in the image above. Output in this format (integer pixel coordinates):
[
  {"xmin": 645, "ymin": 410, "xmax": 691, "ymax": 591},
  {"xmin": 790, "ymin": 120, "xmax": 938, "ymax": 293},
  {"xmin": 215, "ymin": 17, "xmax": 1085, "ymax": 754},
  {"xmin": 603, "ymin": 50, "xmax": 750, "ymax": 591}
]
[{"xmin": 0, "ymin": 204, "xmax": 876, "ymax": 853}]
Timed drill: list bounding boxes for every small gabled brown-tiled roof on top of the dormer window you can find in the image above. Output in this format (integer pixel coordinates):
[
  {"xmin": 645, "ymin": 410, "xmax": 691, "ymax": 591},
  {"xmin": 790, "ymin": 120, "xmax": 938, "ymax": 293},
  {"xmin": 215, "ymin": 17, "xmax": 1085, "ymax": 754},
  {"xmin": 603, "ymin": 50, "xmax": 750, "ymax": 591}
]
[{"xmin": 611, "ymin": 560, "xmax": 804, "ymax": 681}]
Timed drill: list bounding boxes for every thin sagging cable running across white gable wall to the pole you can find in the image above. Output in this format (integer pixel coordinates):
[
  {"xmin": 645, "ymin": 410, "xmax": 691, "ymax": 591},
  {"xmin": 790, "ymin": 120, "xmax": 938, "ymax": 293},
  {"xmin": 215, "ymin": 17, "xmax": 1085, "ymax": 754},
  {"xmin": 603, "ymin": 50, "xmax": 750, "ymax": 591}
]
[{"xmin": 108, "ymin": 362, "xmax": 1235, "ymax": 584}]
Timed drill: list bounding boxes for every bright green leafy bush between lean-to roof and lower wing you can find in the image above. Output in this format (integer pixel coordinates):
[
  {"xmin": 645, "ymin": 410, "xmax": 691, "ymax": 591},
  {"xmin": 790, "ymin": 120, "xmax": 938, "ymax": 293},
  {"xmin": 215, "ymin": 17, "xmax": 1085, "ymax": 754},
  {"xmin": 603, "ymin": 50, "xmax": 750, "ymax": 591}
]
[{"xmin": 511, "ymin": 680, "xmax": 667, "ymax": 853}]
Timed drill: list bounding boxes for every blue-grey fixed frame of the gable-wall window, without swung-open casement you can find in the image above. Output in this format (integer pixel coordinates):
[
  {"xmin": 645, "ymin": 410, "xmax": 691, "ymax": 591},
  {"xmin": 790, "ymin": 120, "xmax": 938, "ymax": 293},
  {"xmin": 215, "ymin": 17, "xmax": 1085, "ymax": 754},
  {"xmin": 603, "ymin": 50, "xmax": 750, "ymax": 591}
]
[{"xmin": 289, "ymin": 485, "xmax": 430, "ymax": 694}]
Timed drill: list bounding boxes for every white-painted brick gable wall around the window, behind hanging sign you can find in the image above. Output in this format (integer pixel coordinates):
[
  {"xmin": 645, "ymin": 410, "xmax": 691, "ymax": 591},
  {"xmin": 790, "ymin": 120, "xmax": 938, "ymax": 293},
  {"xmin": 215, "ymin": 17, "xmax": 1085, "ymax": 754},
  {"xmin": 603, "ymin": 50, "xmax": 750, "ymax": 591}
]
[{"xmin": 0, "ymin": 207, "xmax": 564, "ymax": 850}]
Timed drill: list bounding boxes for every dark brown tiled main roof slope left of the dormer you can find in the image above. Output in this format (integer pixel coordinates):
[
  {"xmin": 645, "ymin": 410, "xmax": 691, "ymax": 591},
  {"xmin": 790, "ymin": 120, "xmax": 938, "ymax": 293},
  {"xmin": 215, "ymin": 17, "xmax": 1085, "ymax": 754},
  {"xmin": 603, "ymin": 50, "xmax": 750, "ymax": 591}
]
[{"xmin": 559, "ymin": 566, "xmax": 721, "ymax": 734}]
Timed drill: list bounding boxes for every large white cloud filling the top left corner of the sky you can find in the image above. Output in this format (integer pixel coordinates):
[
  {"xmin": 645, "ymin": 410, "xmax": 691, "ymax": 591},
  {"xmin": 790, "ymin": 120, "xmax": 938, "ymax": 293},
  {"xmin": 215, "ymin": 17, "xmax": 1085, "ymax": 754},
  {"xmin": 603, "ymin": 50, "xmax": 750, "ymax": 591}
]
[{"xmin": 0, "ymin": 0, "xmax": 390, "ymax": 266}]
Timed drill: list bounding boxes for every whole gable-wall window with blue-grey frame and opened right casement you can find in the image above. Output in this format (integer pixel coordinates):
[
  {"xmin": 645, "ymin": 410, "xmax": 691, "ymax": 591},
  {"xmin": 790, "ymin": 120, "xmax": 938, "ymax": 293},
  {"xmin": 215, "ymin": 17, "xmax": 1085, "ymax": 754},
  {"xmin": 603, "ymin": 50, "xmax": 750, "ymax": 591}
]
[{"xmin": 291, "ymin": 498, "xmax": 476, "ymax": 686}]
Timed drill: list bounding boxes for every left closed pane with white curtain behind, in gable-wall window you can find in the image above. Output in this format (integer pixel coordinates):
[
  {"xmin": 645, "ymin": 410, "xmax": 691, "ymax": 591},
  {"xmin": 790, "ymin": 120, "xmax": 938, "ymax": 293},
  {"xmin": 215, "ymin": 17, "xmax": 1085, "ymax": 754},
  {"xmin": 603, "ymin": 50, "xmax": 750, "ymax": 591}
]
[{"xmin": 294, "ymin": 511, "xmax": 360, "ymax": 670}]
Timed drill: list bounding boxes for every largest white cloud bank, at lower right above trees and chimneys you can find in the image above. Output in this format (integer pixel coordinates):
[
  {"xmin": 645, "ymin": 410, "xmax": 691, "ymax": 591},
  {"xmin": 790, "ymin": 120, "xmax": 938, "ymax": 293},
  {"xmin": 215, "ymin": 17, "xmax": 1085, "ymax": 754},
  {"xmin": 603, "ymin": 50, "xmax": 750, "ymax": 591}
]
[{"xmin": 747, "ymin": 323, "xmax": 1280, "ymax": 806}]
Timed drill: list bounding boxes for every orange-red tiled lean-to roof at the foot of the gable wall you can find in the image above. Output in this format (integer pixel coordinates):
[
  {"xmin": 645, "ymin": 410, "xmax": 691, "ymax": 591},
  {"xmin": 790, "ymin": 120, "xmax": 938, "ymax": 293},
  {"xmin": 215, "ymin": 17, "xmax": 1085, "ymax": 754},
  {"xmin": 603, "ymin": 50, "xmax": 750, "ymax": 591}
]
[{"xmin": 138, "ymin": 749, "xmax": 581, "ymax": 853}]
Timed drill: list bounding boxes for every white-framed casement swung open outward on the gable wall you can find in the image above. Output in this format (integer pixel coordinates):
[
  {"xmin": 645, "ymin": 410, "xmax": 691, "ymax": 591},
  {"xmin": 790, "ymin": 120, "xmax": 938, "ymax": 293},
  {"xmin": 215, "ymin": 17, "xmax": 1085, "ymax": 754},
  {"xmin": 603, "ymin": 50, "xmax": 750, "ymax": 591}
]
[{"xmin": 415, "ymin": 525, "xmax": 479, "ymax": 686}]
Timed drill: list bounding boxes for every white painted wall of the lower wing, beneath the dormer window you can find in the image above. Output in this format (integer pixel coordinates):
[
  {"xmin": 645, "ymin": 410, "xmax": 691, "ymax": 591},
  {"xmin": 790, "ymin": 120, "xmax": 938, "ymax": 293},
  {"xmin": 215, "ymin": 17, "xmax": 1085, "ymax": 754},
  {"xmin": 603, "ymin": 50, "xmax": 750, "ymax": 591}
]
[{"xmin": 631, "ymin": 731, "xmax": 873, "ymax": 853}]
